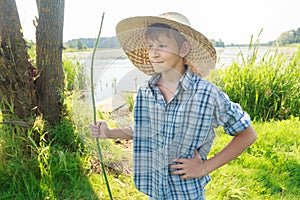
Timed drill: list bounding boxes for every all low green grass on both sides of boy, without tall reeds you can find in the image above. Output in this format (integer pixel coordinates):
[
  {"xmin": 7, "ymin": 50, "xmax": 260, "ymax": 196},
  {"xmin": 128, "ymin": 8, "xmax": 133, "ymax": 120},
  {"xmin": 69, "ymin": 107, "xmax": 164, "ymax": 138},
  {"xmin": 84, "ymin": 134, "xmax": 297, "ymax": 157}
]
[{"xmin": 0, "ymin": 95, "xmax": 300, "ymax": 200}]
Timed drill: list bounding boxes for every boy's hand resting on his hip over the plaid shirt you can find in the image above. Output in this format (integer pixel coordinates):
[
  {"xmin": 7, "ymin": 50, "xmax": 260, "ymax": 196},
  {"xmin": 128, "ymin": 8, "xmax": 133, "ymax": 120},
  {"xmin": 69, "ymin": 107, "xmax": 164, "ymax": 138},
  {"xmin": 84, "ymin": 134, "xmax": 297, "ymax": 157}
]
[{"xmin": 170, "ymin": 151, "xmax": 206, "ymax": 179}]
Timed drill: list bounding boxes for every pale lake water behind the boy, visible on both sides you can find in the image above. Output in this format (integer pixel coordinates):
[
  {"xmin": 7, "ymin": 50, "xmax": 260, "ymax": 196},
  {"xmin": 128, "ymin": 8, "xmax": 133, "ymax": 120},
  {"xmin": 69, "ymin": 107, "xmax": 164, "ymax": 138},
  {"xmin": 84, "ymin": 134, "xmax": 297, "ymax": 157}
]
[{"xmin": 76, "ymin": 47, "xmax": 297, "ymax": 102}]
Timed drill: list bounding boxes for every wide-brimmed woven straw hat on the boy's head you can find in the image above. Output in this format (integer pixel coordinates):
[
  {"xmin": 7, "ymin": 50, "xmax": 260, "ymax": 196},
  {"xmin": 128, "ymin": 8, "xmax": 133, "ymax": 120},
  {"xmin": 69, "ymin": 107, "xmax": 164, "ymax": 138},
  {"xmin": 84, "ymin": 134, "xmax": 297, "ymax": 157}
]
[{"xmin": 116, "ymin": 12, "xmax": 216, "ymax": 77}]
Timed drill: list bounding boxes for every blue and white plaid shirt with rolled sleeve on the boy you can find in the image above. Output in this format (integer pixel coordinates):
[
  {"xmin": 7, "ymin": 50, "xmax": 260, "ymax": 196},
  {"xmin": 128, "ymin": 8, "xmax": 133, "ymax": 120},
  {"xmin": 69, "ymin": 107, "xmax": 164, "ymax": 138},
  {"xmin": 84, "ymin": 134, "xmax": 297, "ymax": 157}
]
[{"xmin": 133, "ymin": 68, "xmax": 250, "ymax": 200}]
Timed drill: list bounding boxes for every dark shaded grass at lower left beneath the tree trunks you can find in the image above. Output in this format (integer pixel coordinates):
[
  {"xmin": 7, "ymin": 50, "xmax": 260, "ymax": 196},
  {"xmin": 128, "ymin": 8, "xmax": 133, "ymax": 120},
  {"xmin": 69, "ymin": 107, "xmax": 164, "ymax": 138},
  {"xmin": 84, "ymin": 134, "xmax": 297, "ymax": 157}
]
[{"xmin": 0, "ymin": 118, "xmax": 99, "ymax": 200}]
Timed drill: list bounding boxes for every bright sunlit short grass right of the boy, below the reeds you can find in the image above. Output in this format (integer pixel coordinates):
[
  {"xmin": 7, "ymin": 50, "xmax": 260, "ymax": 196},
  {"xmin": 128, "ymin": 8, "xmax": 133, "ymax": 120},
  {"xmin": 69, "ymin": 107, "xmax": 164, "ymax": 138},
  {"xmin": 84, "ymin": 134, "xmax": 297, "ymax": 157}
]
[{"xmin": 206, "ymin": 118, "xmax": 300, "ymax": 200}]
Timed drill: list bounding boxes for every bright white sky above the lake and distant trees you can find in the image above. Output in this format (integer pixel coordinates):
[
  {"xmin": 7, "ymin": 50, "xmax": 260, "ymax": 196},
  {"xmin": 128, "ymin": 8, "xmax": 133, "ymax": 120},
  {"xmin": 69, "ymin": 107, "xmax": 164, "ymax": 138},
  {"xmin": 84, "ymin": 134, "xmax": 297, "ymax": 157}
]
[{"xmin": 16, "ymin": 0, "xmax": 300, "ymax": 44}]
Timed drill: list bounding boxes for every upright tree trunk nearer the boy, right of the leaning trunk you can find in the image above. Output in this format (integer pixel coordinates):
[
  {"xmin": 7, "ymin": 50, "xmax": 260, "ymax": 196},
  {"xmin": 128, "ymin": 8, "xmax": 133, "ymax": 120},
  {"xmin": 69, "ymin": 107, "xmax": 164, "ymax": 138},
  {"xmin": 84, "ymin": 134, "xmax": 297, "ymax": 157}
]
[{"xmin": 36, "ymin": 0, "xmax": 65, "ymax": 124}]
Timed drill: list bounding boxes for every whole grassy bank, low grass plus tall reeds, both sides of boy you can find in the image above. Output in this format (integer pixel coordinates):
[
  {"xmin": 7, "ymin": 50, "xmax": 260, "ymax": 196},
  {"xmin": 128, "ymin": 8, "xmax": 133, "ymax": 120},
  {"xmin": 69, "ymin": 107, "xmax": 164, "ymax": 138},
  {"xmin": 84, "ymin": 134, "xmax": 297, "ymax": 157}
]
[{"xmin": 0, "ymin": 44, "xmax": 300, "ymax": 200}]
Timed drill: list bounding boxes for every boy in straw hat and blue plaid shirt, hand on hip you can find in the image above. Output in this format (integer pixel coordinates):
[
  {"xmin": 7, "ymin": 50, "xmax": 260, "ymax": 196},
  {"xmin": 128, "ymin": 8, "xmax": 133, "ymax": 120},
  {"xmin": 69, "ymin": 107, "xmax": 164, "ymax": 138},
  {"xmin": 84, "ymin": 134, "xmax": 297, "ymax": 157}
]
[{"xmin": 91, "ymin": 12, "xmax": 257, "ymax": 200}]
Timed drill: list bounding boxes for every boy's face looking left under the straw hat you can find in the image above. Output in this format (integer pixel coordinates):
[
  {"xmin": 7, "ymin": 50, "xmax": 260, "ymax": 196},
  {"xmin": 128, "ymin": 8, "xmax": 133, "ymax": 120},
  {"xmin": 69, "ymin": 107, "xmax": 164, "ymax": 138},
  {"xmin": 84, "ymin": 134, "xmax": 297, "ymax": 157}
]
[{"xmin": 148, "ymin": 34, "xmax": 184, "ymax": 73}]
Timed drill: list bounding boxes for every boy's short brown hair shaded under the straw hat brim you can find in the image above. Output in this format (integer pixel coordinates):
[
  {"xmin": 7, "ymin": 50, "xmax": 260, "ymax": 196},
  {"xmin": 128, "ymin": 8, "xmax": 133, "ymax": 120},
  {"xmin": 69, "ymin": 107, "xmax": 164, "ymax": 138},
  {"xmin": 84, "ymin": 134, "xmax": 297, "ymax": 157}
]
[{"xmin": 146, "ymin": 23, "xmax": 187, "ymax": 48}]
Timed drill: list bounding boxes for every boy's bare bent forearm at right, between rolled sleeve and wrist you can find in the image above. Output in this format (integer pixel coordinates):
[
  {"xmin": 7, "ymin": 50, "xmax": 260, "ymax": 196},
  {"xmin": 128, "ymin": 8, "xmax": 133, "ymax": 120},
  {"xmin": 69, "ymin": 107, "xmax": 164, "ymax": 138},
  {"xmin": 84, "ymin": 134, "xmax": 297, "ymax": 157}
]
[{"xmin": 204, "ymin": 126, "xmax": 257, "ymax": 174}]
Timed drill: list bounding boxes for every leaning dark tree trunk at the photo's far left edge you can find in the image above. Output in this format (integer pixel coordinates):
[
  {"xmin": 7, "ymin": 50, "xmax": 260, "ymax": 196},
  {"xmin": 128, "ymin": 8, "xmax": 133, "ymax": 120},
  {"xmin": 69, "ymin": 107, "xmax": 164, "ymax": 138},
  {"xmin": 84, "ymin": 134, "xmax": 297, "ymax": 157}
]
[{"xmin": 0, "ymin": 0, "xmax": 37, "ymax": 120}]
